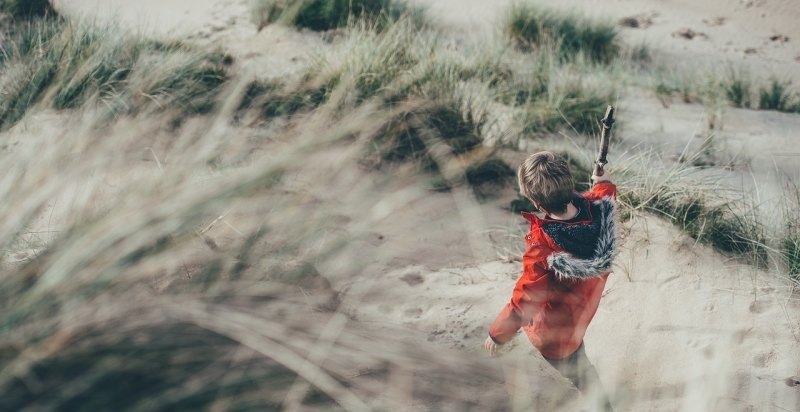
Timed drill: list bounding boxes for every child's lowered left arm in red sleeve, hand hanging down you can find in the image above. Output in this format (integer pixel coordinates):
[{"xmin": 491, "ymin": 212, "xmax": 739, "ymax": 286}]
[{"xmin": 484, "ymin": 244, "xmax": 550, "ymax": 348}]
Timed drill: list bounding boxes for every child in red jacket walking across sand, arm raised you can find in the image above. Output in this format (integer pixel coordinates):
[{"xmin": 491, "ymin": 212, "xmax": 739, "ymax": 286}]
[{"xmin": 484, "ymin": 152, "xmax": 617, "ymax": 410}]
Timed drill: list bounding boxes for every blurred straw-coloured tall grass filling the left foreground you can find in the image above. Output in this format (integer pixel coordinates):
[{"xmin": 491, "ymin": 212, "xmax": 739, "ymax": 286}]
[{"xmin": 0, "ymin": 67, "xmax": 524, "ymax": 411}]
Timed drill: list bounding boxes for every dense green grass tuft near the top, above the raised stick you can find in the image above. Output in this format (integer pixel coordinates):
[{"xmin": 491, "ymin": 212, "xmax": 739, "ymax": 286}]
[{"xmin": 503, "ymin": 3, "xmax": 620, "ymax": 63}]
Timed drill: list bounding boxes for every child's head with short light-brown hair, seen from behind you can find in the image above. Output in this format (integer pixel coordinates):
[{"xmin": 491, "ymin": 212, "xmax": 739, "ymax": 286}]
[{"xmin": 517, "ymin": 152, "xmax": 574, "ymax": 214}]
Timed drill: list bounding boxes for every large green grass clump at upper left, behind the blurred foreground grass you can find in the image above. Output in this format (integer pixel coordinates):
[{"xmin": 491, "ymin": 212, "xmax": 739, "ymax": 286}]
[{"xmin": 0, "ymin": 20, "xmax": 228, "ymax": 128}]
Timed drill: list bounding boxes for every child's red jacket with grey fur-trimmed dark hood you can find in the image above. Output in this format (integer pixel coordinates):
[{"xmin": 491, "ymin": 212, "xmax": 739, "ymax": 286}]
[{"xmin": 489, "ymin": 182, "xmax": 617, "ymax": 359}]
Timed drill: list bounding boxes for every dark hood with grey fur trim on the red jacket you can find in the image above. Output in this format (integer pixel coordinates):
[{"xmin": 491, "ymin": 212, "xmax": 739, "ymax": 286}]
[{"xmin": 541, "ymin": 195, "xmax": 617, "ymax": 280}]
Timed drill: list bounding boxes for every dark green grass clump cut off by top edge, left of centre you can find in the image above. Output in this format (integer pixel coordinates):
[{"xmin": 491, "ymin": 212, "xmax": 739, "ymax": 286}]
[{"xmin": 251, "ymin": 0, "xmax": 424, "ymax": 31}]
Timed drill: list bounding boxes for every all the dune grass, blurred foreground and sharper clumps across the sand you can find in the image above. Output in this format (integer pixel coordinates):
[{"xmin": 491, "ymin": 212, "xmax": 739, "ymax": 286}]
[{"xmin": 0, "ymin": 0, "xmax": 800, "ymax": 411}]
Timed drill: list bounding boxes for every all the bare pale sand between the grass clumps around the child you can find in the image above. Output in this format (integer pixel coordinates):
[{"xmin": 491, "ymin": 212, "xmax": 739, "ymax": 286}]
[{"xmin": 36, "ymin": 0, "xmax": 800, "ymax": 411}]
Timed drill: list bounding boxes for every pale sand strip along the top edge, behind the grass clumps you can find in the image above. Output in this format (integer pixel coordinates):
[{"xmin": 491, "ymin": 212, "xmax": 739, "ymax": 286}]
[{"xmin": 55, "ymin": 0, "xmax": 800, "ymax": 80}]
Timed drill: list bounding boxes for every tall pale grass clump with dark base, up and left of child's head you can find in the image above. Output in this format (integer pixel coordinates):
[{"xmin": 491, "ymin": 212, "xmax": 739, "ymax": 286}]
[{"xmin": 292, "ymin": 19, "xmax": 508, "ymax": 197}]
